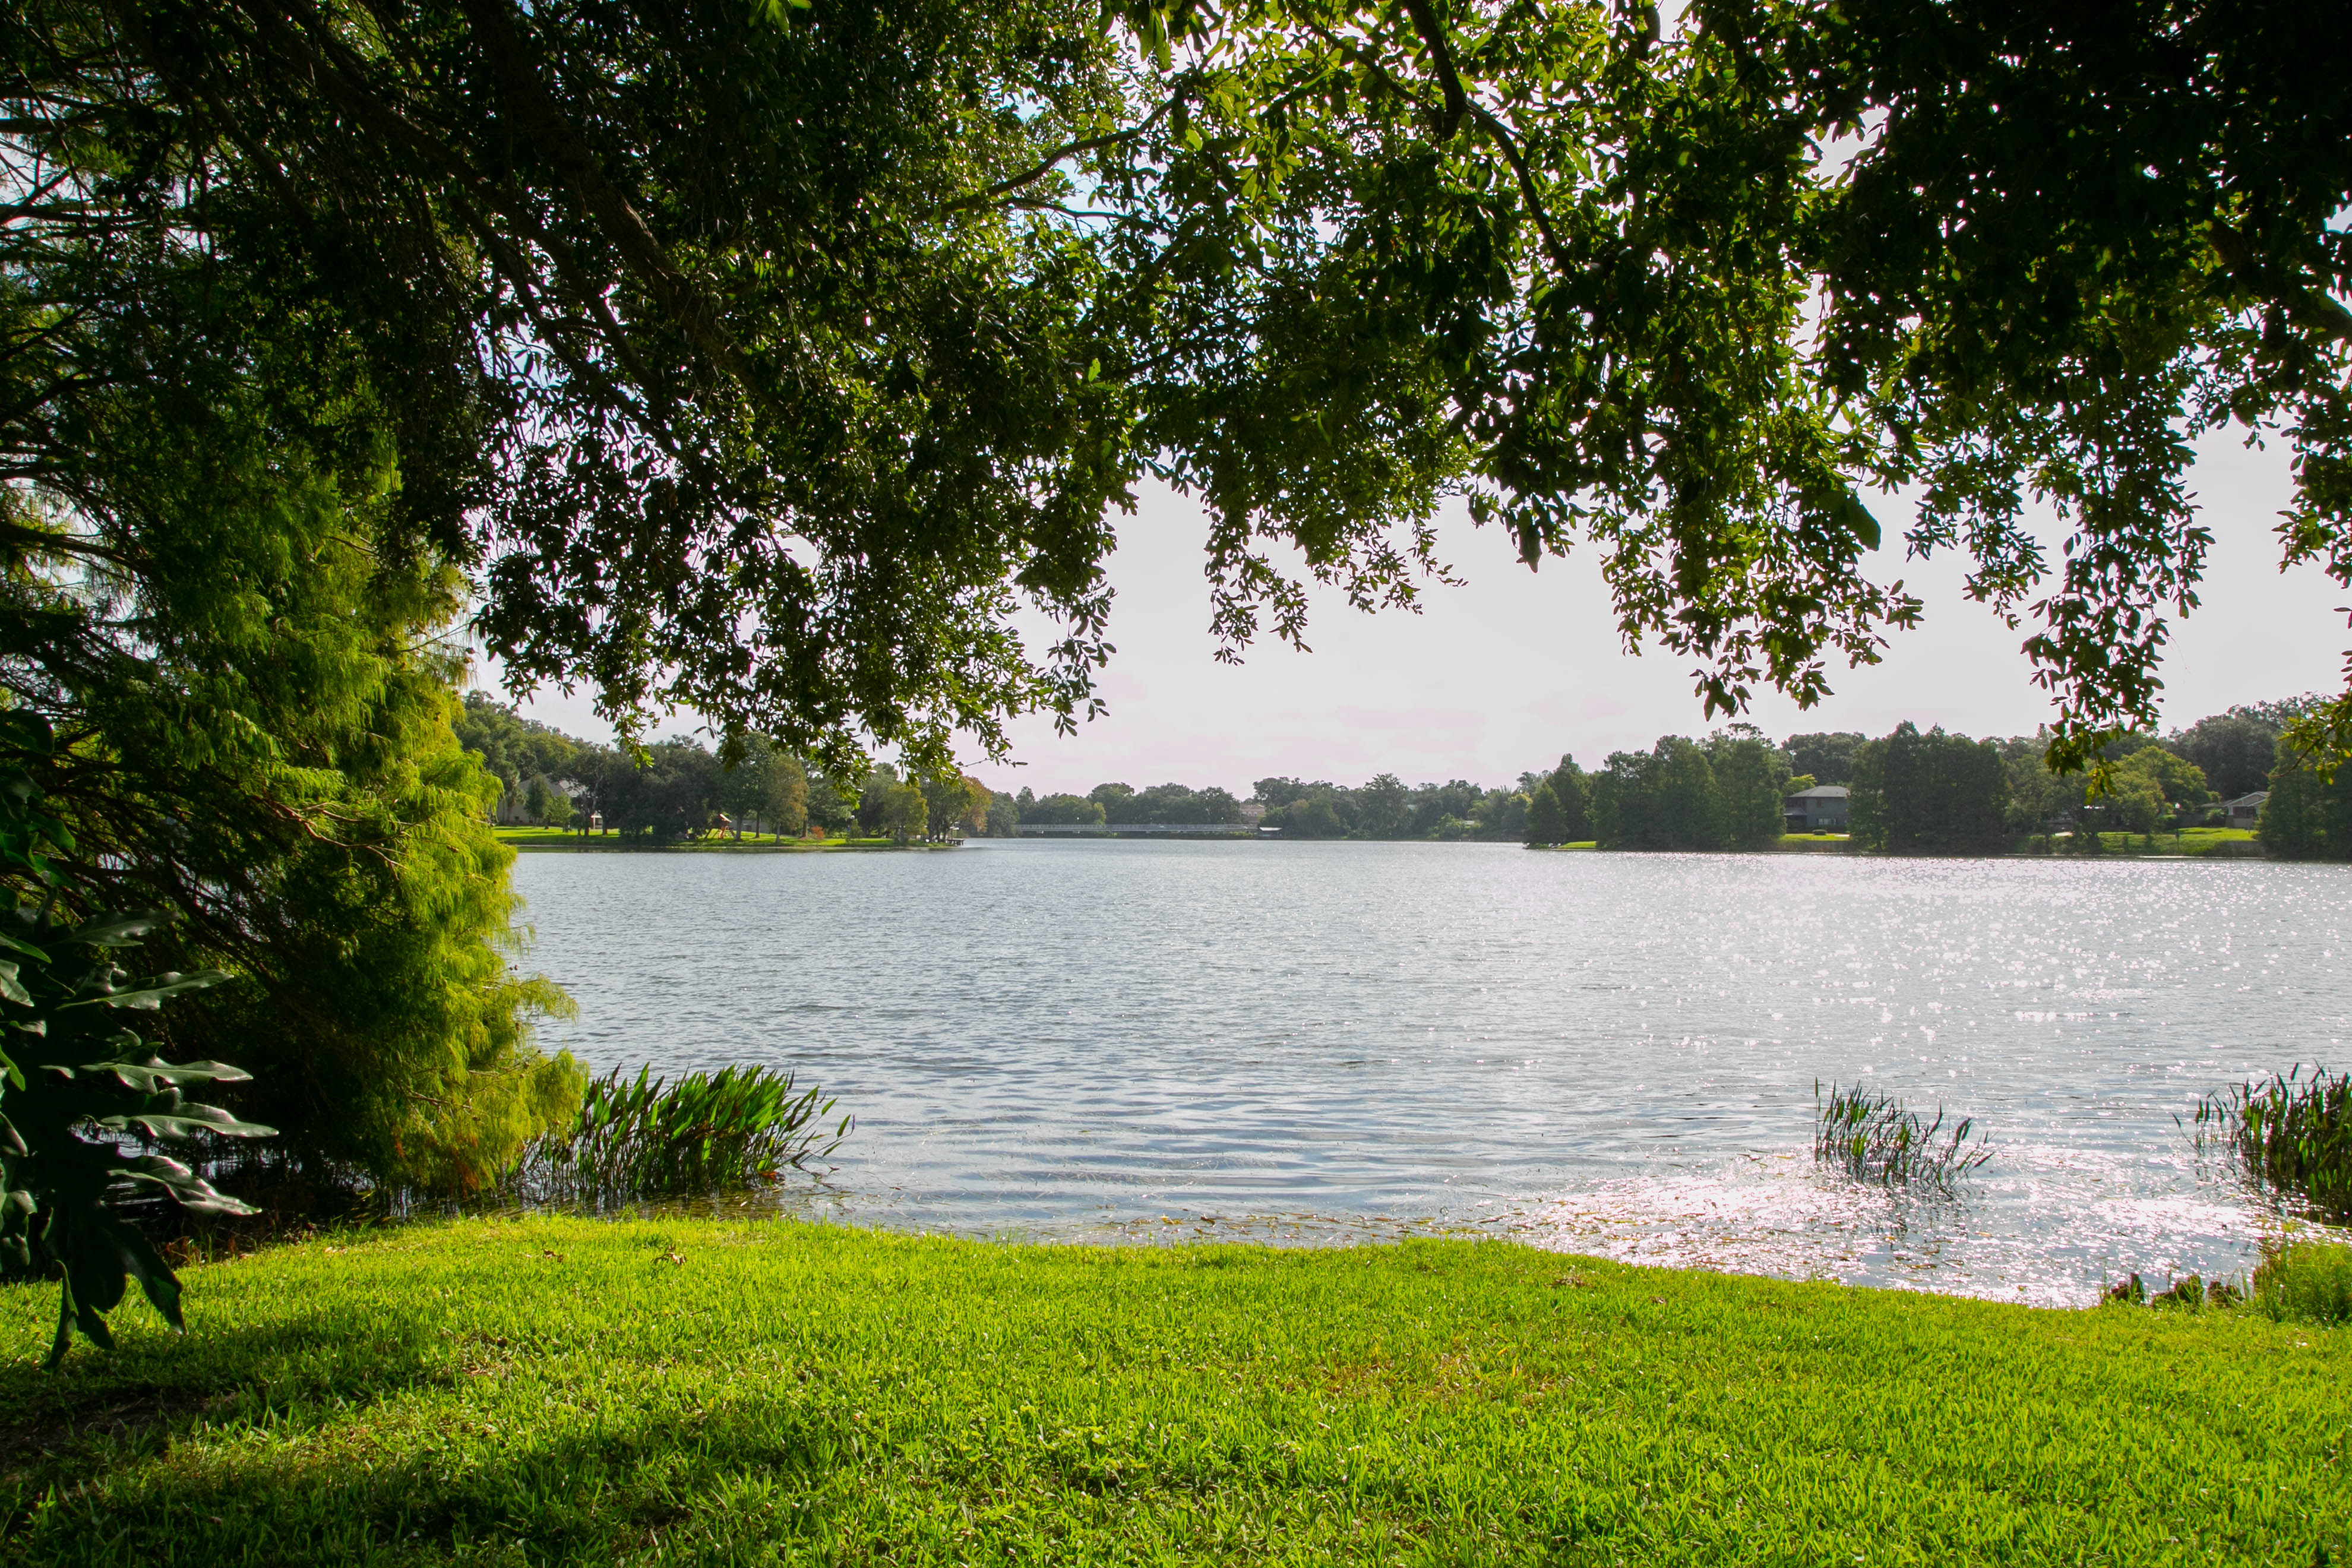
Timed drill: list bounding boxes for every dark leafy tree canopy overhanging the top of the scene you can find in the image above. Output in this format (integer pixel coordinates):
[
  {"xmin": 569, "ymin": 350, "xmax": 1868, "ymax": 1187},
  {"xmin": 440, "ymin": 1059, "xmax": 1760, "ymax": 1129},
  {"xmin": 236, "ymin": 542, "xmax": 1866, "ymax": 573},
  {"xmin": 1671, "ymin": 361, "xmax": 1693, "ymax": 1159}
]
[{"xmin": 0, "ymin": 0, "xmax": 2352, "ymax": 773}]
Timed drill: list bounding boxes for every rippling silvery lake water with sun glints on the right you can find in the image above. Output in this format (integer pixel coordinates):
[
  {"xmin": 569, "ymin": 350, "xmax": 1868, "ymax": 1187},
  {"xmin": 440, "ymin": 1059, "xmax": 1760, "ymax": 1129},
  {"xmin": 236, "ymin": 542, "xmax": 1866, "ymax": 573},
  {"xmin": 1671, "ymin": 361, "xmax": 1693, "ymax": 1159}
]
[{"xmin": 515, "ymin": 842, "xmax": 2352, "ymax": 1303}]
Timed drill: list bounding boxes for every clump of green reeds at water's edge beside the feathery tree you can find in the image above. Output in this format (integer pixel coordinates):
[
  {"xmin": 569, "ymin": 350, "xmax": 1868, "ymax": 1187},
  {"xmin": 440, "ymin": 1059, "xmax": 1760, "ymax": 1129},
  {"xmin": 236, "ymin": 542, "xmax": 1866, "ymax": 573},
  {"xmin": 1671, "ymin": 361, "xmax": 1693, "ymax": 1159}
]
[{"xmin": 510, "ymin": 1067, "xmax": 852, "ymax": 1204}]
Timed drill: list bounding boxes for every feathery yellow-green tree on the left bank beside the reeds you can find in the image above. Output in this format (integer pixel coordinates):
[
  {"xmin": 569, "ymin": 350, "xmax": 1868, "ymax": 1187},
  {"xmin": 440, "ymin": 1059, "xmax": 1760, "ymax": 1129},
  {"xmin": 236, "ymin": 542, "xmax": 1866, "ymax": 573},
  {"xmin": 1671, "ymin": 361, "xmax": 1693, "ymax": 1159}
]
[{"xmin": 0, "ymin": 76, "xmax": 578, "ymax": 1187}]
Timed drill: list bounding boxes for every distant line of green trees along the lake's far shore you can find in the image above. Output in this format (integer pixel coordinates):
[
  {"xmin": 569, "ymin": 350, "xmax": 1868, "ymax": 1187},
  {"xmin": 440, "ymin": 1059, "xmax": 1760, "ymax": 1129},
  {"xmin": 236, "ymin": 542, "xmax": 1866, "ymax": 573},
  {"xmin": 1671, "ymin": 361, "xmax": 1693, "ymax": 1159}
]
[{"xmin": 456, "ymin": 691, "xmax": 2352, "ymax": 861}]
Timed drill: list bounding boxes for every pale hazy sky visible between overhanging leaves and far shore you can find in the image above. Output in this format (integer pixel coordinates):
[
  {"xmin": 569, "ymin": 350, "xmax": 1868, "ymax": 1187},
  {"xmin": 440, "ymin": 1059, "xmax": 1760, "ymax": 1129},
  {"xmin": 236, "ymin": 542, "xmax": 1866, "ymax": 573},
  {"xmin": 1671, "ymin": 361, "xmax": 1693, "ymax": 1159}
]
[{"xmin": 486, "ymin": 437, "xmax": 2352, "ymax": 797}]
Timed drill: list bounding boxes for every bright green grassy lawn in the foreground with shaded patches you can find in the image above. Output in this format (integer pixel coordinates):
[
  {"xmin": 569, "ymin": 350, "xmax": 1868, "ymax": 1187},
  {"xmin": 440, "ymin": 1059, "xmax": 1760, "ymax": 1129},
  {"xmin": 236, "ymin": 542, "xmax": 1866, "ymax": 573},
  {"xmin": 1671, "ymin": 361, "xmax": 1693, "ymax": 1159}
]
[{"xmin": 0, "ymin": 1220, "xmax": 2352, "ymax": 1568}]
